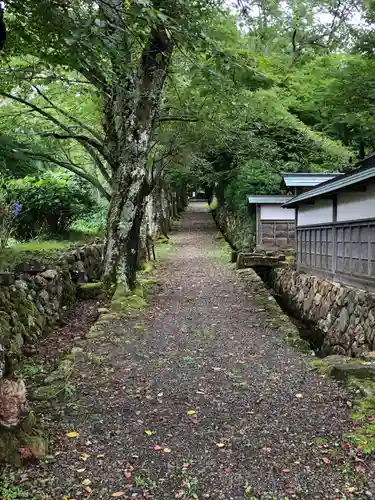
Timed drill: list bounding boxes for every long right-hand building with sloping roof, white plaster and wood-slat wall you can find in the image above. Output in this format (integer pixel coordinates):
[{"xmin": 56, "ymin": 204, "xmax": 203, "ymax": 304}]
[{"xmin": 284, "ymin": 153, "xmax": 375, "ymax": 291}]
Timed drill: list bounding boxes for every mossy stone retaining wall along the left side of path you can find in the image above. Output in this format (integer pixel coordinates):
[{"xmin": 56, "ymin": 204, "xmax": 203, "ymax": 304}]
[{"xmin": 0, "ymin": 244, "xmax": 103, "ymax": 379}]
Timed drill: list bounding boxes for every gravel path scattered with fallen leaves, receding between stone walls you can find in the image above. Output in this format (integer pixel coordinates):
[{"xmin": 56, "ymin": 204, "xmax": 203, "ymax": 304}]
[{"xmin": 28, "ymin": 205, "xmax": 375, "ymax": 500}]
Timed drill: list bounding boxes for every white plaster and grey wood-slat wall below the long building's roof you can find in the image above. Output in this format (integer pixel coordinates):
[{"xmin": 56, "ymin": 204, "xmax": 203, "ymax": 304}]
[{"xmin": 297, "ymin": 184, "xmax": 375, "ymax": 291}]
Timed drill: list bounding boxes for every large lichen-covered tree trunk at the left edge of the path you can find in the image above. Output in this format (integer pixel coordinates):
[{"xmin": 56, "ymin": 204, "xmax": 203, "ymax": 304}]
[{"xmin": 103, "ymin": 27, "xmax": 173, "ymax": 289}]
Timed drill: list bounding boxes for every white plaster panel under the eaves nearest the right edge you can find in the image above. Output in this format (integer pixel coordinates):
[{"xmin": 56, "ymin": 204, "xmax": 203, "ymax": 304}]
[{"xmin": 337, "ymin": 183, "xmax": 375, "ymax": 222}]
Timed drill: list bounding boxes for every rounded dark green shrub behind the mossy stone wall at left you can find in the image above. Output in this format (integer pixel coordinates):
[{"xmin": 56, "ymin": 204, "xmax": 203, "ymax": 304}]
[{"xmin": 3, "ymin": 172, "xmax": 94, "ymax": 239}]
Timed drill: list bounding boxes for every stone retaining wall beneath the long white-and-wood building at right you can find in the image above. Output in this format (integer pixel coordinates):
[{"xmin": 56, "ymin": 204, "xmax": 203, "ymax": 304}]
[{"xmin": 267, "ymin": 268, "xmax": 375, "ymax": 357}]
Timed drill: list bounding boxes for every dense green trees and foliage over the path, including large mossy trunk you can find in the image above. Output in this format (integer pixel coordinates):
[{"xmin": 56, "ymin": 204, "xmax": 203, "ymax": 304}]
[{"xmin": 0, "ymin": 0, "xmax": 375, "ymax": 287}]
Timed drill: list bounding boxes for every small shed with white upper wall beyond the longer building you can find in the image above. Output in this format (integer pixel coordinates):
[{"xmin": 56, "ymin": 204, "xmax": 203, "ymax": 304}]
[{"xmin": 247, "ymin": 195, "xmax": 295, "ymax": 248}]
